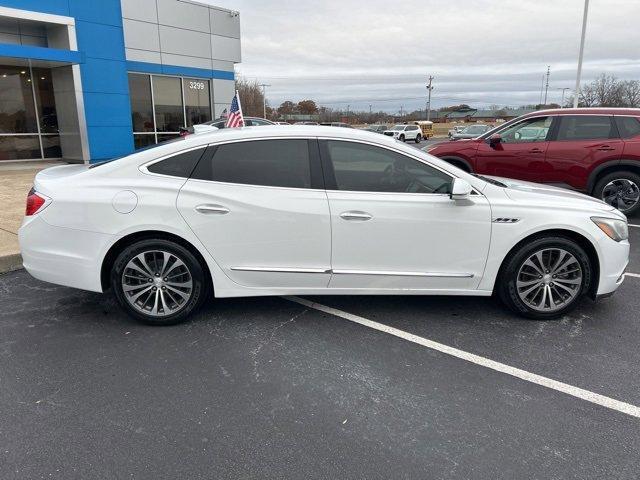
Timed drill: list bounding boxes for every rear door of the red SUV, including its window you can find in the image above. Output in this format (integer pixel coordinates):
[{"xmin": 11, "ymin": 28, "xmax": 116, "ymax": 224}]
[{"xmin": 542, "ymin": 115, "xmax": 624, "ymax": 190}]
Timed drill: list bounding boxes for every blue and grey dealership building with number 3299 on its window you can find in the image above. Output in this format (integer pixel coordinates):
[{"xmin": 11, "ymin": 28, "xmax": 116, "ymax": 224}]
[{"xmin": 0, "ymin": 0, "xmax": 240, "ymax": 162}]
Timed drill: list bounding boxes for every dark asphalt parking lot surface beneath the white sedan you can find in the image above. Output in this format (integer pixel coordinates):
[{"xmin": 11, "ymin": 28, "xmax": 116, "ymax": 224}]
[{"xmin": 0, "ymin": 213, "xmax": 640, "ymax": 479}]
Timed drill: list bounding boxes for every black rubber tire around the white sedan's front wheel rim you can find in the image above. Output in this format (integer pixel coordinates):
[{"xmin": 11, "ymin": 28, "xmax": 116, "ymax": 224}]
[{"xmin": 496, "ymin": 236, "xmax": 593, "ymax": 320}]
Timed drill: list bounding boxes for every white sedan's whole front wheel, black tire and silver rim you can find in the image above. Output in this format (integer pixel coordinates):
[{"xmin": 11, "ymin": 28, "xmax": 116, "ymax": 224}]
[{"xmin": 497, "ymin": 237, "xmax": 592, "ymax": 320}]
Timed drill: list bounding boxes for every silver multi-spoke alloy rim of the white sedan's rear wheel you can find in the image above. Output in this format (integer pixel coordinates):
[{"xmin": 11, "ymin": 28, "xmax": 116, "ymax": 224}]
[{"xmin": 121, "ymin": 250, "xmax": 193, "ymax": 317}]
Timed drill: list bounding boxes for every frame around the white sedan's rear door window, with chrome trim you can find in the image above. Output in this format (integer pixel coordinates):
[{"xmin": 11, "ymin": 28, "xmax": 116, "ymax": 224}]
[{"xmin": 189, "ymin": 136, "xmax": 325, "ymax": 191}]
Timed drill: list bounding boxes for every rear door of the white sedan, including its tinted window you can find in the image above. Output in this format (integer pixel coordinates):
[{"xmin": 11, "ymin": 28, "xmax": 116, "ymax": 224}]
[{"xmin": 178, "ymin": 139, "xmax": 331, "ymax": 288}]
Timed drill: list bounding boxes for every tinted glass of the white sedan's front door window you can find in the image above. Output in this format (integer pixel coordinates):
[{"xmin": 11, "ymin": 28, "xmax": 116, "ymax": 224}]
[{"xmin": 327, "ymin": 141, "xmax": 451, "ymax": 193}]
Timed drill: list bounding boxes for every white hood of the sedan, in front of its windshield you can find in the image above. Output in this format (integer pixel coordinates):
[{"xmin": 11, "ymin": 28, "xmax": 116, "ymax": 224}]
[{"xmin": 489, "ymin": 176, "xmax": 626, "ymax": 218}]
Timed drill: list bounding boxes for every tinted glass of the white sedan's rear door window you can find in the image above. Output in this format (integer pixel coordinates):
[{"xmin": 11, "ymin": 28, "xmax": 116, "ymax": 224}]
[{"xmin": 193, "ymin": 140, "xmax": 311, "ymax": 188}]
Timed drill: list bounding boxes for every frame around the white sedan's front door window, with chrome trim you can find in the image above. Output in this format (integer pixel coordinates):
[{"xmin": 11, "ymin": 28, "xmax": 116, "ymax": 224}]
[{"xmin": 318, "ymin": 137, "xmax": 458, "ymax": 198}]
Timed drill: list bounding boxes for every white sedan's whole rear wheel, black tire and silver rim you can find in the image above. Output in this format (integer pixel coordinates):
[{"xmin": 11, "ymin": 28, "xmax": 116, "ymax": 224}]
[{"xmin": 111, "ymin": 239, "xmax": 206, "ymax": 325}]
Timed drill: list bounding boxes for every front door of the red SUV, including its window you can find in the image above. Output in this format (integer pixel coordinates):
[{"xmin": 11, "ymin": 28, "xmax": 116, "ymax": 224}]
[{"xmin": 474, "ymin": 117, "xmax": 553, "ymax": 182}]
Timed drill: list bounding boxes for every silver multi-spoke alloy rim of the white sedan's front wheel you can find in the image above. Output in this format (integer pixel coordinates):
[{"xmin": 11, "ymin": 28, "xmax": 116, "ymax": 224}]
[{"xmin": 516, "ymin": 248, "xmax": 582, "ymax": 313}]
